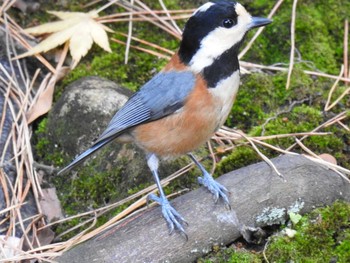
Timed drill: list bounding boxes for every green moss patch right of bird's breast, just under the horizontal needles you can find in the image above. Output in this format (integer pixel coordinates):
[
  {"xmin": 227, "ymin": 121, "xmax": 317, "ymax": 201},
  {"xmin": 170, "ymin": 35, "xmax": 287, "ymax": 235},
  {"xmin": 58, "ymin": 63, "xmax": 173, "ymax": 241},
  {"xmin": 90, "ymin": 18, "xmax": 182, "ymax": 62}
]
[{"xmin": 226, "ymin": 68, "xmax": 323, "ymax": 130}]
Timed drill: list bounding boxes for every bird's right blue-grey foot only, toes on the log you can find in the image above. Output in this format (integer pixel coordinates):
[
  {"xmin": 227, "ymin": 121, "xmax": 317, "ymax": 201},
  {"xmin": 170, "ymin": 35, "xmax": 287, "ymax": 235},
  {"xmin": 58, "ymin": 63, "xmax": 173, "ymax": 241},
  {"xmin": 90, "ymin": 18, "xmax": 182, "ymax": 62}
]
[{"xmin": 198, "ymin": 172, "xmax": 231, "ymax": 209}]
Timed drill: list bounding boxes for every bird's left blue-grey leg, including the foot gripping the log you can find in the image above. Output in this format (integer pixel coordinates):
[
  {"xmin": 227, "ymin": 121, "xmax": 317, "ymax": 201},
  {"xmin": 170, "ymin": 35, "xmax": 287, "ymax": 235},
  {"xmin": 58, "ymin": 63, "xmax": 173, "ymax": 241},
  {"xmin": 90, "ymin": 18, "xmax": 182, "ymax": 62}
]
[{"xmin": 147, "ymin": 154, "xmax": 187, "ymax": 239}]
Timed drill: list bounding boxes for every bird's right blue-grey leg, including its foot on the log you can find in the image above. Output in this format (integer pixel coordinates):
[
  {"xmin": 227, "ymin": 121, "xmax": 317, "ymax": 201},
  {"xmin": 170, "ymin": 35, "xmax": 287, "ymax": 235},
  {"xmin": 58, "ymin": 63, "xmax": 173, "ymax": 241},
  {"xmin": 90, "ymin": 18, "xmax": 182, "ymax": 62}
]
[{"xmin": 188, "ymin": 153, "xmax": 230, "ymax": 208}]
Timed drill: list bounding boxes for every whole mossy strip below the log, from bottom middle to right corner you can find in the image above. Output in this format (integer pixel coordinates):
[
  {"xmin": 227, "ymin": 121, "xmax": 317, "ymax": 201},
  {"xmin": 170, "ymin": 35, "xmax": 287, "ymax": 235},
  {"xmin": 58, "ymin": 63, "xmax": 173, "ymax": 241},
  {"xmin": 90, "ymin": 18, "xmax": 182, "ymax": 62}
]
[{"xmin": 197, "ymin": 201, "xmax": 350, "ymax": 263}]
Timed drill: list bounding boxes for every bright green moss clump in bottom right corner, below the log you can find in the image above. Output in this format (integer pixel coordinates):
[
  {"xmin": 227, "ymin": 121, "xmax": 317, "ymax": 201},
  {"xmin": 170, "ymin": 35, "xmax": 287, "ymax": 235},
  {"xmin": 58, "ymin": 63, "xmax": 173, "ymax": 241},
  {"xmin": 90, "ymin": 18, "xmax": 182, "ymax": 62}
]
[{"xmin": 266, "ymin": 202, "xmax": 350, "ymax": 262}]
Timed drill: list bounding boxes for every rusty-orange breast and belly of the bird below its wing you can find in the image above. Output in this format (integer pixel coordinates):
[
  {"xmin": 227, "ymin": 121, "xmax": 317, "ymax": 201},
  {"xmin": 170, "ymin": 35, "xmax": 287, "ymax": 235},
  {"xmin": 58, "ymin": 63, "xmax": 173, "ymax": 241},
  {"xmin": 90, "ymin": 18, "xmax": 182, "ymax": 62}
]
[{"xmin": 131, "ymin": 78, "xmax": 222, "ymax": 157}]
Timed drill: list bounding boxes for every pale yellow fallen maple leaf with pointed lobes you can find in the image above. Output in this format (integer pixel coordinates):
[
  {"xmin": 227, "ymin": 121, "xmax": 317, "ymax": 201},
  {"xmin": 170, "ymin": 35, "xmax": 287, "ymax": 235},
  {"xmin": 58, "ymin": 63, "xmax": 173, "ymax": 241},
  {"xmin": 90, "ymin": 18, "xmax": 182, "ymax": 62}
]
[{"xmin": 17, "ymin": 11, "xmax": 113, "ymax": 67}]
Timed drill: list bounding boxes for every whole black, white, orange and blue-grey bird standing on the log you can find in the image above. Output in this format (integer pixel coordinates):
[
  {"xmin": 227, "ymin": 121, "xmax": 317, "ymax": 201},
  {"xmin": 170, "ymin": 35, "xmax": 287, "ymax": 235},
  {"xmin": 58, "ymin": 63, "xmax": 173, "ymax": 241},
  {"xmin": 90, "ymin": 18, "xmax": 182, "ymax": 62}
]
[{"xmin": 60, "ymin": 1, "xmax": 271, "ymax": 236}]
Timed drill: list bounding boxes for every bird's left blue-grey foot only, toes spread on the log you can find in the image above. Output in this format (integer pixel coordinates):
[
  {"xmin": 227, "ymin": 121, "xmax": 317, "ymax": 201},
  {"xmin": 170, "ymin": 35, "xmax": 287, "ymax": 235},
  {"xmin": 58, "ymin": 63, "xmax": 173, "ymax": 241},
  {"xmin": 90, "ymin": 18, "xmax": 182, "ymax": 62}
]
[{"xmin": 147, "ymin": 194, "xmax": 188, "ymax": 240}]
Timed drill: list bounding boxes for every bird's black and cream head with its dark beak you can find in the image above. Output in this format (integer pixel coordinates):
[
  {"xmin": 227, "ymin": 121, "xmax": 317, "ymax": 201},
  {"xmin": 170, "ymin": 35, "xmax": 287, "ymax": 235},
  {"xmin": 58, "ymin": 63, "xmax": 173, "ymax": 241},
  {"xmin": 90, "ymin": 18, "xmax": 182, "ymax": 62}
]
[{"xmin": 179, "ymin": 0, "xmax": 271, "ymax": 72}]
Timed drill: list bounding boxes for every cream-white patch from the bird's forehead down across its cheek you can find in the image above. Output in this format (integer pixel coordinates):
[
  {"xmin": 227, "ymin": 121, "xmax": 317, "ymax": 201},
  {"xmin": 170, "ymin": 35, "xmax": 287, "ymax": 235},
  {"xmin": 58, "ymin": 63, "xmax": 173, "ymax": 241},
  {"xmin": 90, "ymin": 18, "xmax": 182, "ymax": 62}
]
[{"xmin": 189, "ymin": 3, "xmax": 252, "ymax": 73}]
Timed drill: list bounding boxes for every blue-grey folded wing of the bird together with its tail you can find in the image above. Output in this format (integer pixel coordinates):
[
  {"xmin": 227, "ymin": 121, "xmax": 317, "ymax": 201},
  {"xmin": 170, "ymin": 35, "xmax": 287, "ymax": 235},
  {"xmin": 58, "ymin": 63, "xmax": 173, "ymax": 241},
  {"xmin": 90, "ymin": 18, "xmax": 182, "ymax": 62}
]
[{"xmin": 59, "ymin": 71, "xmax": 195, "ymax": 173}]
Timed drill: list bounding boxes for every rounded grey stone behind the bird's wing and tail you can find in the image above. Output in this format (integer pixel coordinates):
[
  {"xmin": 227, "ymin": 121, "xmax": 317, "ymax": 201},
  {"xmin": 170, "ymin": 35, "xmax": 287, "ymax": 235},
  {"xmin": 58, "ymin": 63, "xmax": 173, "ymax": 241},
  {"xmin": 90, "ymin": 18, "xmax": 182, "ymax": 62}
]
[{"xmin": 48, "ymin": 77, "xmax": 131, "ymax": 158}]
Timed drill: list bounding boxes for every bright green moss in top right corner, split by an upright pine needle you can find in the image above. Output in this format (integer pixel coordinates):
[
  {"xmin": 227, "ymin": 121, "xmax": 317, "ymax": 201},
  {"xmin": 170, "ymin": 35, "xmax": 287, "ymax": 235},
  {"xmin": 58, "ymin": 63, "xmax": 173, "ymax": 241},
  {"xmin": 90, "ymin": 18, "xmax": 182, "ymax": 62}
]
[{"xmin": 243, "ymin": 0, "xmax": 350, "ymax": 74}]
